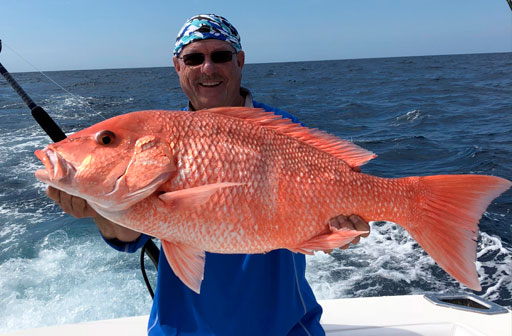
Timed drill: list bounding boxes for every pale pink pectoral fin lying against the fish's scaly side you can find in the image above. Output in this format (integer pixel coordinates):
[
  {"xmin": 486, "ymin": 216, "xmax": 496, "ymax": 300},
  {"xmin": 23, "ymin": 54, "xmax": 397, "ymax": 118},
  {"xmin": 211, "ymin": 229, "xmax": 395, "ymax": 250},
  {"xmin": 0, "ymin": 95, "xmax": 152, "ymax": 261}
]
[{"xmin": 158, "ymin": 182, "xmax": 245, "ymax": 207}]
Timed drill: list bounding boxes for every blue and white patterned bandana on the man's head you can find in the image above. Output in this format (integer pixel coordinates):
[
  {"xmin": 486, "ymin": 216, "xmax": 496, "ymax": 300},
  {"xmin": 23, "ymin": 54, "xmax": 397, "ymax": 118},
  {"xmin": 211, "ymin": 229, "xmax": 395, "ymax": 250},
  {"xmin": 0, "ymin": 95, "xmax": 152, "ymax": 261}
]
[{"xmin": 173, "ymin": 14, "xmax": 242, "ymax": 56}]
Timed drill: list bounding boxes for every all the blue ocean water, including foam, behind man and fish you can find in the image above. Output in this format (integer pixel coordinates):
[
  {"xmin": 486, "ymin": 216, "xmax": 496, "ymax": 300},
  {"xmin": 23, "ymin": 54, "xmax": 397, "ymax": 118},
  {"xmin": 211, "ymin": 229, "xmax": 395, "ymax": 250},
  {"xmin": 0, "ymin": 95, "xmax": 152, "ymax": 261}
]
[{"xmin": 0, "ymin": 53, "xmax": 512, "ymax": 331}]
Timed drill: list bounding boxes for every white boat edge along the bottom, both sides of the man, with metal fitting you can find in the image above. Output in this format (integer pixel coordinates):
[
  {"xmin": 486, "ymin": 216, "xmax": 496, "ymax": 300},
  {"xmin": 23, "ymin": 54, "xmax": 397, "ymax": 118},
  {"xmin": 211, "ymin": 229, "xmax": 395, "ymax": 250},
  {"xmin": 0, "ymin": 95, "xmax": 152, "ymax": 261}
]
[{"xmin": 0, "ymin": 293, "xmax": 512, "ymax": 336}]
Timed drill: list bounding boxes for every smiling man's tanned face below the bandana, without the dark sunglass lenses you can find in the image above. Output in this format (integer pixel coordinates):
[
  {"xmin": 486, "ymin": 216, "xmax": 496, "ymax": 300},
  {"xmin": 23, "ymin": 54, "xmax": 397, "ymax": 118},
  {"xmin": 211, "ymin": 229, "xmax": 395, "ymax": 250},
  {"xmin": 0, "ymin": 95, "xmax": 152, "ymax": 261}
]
[{"xmin": 173, "ymin": 39, "xmax": 245, "ymax": 110}]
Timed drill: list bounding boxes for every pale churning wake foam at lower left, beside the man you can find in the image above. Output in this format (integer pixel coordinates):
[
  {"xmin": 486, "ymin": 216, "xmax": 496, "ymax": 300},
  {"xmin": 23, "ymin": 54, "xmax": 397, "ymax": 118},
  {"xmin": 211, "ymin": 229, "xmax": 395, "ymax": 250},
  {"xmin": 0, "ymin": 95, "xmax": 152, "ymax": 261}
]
[{"xmin": 0, "ymin": 230, "xmax": 155, "ymax": 332}]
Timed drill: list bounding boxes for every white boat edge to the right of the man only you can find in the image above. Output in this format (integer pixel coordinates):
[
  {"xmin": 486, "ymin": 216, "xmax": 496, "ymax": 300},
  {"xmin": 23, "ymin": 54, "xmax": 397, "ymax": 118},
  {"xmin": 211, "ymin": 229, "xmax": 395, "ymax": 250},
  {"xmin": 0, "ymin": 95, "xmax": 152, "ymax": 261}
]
[{"xmin": 320, "ymin": 295, "xmax": 512, "ymax": 336}]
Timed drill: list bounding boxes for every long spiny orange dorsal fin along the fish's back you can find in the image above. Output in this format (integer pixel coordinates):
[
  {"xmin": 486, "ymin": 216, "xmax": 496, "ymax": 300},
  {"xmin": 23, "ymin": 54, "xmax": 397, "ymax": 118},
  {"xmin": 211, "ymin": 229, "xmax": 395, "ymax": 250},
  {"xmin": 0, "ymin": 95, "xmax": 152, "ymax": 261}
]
[{"xmin": 203, "ymin": 107, "xmax": 377, "ymax": 167}]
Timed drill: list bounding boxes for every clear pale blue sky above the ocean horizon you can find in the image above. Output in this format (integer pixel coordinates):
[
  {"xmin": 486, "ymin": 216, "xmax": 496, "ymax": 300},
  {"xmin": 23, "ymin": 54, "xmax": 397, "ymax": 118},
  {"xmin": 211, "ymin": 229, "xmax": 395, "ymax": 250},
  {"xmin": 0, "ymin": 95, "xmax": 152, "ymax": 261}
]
[{"xmin": 0, "ymin": 0, "xmax": 512, "ymax": 72}]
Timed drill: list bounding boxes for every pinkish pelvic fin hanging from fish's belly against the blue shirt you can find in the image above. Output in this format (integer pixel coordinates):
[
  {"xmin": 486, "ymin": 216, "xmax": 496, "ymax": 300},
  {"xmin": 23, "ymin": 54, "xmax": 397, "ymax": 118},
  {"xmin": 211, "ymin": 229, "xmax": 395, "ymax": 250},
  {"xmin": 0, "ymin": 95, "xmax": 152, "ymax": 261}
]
[{"xmin": 162, "ymin": 240, "xmax": 205, "ymax": 294}]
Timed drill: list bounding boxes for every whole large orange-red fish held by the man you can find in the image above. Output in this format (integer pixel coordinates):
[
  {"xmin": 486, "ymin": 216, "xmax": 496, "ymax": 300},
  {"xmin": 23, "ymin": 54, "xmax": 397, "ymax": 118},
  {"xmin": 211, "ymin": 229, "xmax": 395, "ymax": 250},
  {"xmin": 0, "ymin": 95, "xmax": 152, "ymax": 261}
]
[{"xmin": 36, "ymin": 108, "xmax": 511, "ymax": 293}]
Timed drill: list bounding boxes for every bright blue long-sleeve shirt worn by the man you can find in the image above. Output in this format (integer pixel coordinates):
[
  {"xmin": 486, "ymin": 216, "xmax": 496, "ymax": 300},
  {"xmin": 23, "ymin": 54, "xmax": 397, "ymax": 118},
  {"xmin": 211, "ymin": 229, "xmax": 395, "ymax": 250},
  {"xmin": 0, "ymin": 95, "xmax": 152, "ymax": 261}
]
[{"xmin": 107, "ymin": 95, "xmax": 325, "ymax": 336}]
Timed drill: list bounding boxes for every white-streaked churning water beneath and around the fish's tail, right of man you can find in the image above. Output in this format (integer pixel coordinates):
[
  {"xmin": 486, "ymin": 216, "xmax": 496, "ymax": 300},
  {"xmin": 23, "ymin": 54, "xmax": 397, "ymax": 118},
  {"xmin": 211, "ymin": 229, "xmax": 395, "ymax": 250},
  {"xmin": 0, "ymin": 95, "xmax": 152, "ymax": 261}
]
[{"xmin": 306, "ymin": 222, "xmax": 512, "ymax": 308}]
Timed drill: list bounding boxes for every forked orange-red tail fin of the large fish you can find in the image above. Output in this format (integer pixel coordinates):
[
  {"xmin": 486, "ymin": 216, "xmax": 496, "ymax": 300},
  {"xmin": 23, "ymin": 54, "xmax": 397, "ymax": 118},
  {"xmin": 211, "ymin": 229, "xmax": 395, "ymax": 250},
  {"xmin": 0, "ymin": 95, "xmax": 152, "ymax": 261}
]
[{"xmin": 404, "ymin": 175, "xmax": 512, "ymax": 290}]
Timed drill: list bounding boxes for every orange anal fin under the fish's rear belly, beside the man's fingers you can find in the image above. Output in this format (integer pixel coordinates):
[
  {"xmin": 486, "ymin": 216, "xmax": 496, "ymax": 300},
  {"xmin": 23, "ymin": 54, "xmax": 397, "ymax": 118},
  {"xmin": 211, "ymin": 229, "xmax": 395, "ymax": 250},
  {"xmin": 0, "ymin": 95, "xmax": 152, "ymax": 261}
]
[{"xmin": 288, "ymin": 227, "xmax": 368, "ymax": 254}]
